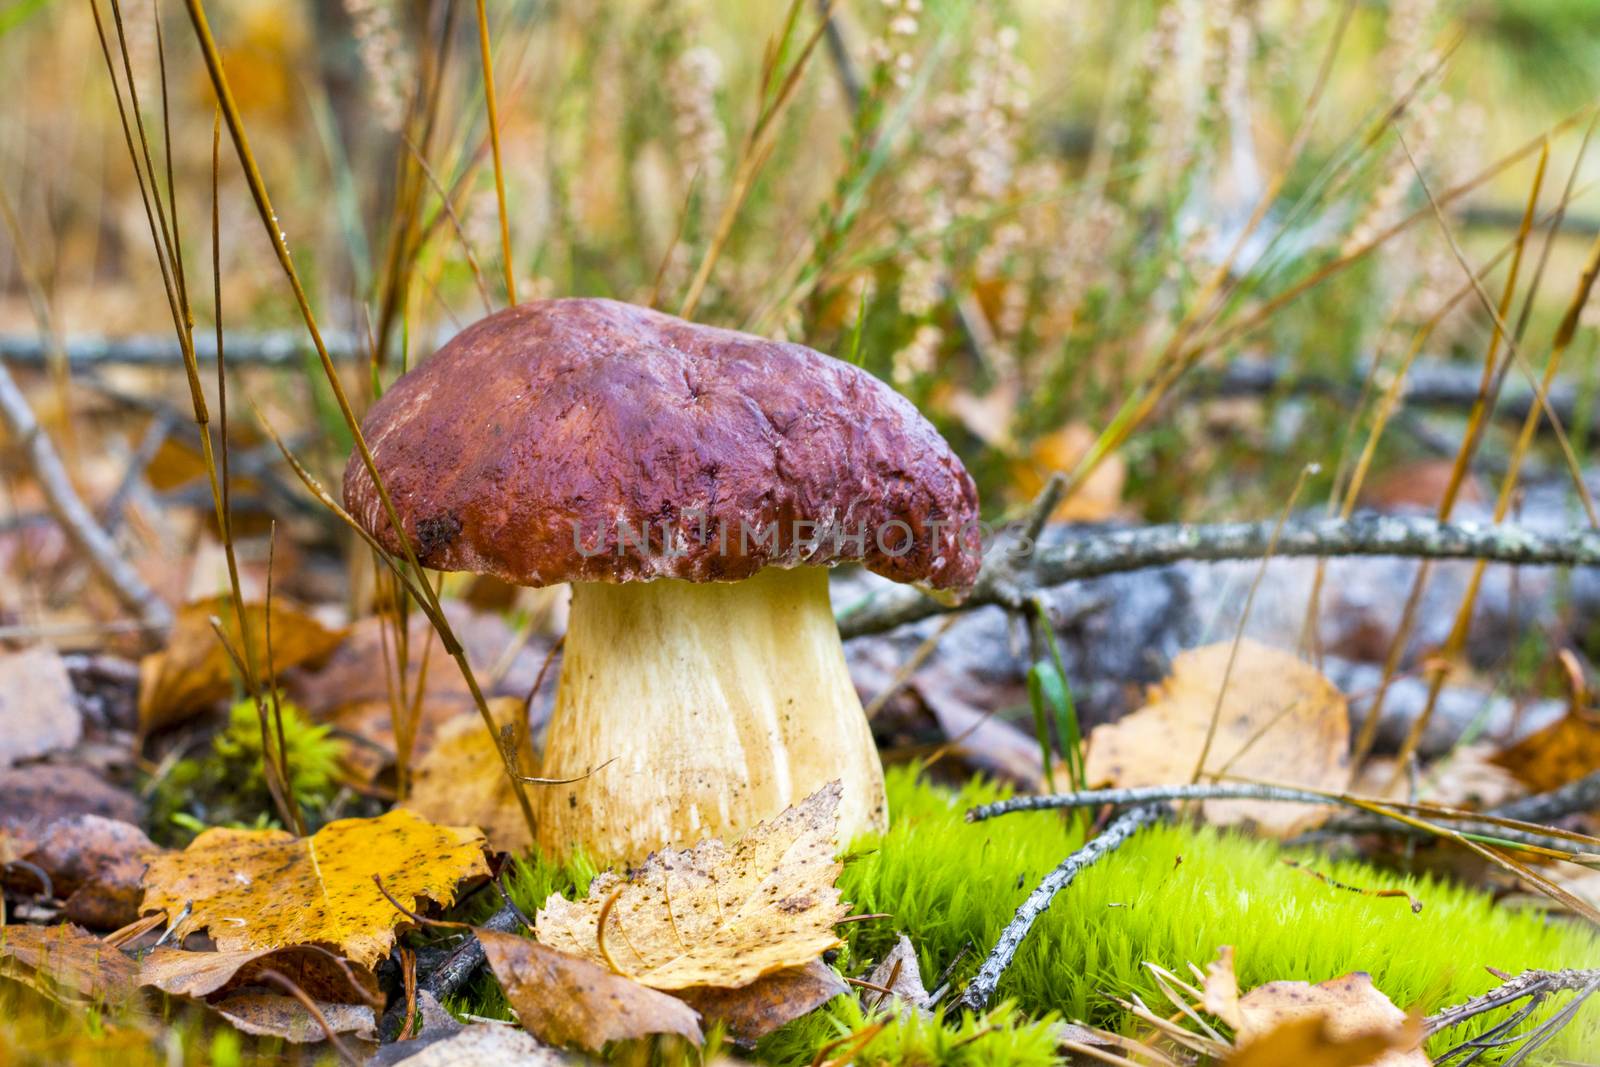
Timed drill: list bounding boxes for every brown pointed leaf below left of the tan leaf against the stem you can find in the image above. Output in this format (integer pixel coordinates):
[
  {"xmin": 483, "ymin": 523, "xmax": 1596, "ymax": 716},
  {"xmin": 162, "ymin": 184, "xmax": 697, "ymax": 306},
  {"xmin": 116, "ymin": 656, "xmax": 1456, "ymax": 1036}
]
[{"xmin": 478, "ymin": 929, "xmax": 704, "ymax": 1053}]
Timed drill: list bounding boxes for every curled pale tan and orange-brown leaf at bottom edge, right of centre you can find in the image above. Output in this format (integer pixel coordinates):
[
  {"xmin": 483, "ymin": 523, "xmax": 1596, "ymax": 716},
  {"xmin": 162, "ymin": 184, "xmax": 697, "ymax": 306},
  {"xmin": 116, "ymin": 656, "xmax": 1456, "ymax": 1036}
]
[{"xmin": 1229, "ymin": 971, "xmax": 1429, "ymax": 1067}]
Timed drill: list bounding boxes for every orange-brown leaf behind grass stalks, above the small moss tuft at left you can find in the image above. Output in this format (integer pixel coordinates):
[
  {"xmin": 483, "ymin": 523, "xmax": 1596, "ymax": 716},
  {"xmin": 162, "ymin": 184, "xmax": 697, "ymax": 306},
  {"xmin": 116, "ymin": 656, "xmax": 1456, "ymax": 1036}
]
[{"xmin": 139, "ymin": 597, "xmax": 344, "ymax": 733}]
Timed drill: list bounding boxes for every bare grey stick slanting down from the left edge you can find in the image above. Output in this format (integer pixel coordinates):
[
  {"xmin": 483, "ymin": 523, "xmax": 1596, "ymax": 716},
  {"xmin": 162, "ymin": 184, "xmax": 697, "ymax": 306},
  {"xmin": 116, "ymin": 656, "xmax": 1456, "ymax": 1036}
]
[{"xmin": 0, "ymin": 362, "xmax": 173, "ymax": 630}]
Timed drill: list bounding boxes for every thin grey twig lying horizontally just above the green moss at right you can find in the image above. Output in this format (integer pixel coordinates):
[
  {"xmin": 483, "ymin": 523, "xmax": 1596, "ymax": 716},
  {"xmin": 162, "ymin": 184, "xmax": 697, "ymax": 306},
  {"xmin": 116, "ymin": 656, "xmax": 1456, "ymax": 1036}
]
[{"xmin": 966, "ymin": 773, "xmax": 1600, "ymax": 854}]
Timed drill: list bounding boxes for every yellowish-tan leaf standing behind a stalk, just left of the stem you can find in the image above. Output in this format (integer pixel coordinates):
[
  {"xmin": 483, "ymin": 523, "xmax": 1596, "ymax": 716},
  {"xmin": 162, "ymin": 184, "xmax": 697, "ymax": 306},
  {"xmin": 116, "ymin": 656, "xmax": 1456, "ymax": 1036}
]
[{"xmin": 405, "ymin": 697, "xmax": 538, "ymax": 853}]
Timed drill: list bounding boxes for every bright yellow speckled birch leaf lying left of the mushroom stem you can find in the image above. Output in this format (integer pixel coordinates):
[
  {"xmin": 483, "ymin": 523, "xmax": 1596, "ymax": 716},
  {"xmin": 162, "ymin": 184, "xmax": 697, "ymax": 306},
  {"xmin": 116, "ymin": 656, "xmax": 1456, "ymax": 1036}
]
[{"xmin": 142, "ymin": 809, "xmax": 488, "ymax": 968}]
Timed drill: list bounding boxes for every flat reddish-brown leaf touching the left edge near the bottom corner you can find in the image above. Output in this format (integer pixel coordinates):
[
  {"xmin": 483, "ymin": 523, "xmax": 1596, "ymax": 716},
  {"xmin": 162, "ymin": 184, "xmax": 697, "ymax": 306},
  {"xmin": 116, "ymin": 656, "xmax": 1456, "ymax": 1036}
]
[{"xmin": 0, "ymin": 923, "xmax": 139, "ymax": 1005}]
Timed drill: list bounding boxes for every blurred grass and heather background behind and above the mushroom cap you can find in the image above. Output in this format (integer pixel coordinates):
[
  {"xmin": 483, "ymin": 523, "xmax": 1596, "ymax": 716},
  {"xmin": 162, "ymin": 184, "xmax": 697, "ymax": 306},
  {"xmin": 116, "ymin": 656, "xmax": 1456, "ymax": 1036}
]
[{"xmin": 0, "ymin": 0, "xmax": 1600, "ymax": 534}]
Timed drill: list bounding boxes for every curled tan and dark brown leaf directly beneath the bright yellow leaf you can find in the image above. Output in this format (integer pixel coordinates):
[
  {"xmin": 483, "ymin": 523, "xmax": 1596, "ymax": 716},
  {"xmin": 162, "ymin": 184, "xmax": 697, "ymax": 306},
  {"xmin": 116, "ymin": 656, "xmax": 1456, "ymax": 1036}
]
[{"xmin": 139, "ymin": 947, "xmax": 379, "ymax": 1003}]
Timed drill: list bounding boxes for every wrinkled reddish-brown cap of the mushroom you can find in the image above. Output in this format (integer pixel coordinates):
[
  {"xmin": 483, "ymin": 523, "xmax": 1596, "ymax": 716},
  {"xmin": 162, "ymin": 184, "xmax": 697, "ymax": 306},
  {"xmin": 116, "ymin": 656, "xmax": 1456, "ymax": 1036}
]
[{"xmin": 344, "ymin": 299, "xmax": 979, "ymax": 589}]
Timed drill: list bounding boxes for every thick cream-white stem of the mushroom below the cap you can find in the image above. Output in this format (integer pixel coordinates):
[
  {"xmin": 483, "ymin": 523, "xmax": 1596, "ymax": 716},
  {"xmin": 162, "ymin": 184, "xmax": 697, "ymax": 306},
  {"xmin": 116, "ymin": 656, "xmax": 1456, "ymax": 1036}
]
[{"xmin": 534, "ymin": 566, "xmax": 888, "ymax": 861}]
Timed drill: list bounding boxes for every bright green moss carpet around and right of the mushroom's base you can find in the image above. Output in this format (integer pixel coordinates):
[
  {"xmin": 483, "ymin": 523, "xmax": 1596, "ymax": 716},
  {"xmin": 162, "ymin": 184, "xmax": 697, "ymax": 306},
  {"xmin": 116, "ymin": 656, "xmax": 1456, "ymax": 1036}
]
[{"xmin": 448, "ymin": 768, "xmax": 1600, "ymax": 1067}]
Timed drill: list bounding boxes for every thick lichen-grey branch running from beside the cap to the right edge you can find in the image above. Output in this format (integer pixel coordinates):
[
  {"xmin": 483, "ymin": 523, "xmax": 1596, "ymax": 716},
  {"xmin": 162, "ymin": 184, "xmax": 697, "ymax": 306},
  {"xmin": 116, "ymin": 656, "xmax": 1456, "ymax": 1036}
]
[{"xmin": 838, "ymin": 515, "xmax": 1600, "ymax": 637}]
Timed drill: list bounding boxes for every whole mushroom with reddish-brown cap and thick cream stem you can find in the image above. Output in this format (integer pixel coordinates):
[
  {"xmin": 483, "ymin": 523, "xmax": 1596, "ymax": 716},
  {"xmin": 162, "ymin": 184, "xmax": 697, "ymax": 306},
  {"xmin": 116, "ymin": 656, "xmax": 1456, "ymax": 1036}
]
[{"xmin": 344, "ymin": 299, "xmax": 979, "ymax": 859}]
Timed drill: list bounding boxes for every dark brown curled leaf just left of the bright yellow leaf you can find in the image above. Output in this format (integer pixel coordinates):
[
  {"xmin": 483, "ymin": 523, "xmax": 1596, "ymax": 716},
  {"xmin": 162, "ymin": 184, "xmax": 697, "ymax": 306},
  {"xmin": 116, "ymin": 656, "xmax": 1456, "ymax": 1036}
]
[{"xmin": 27, "ymin": 814, "xmax": 162, "ymax": 929}]
